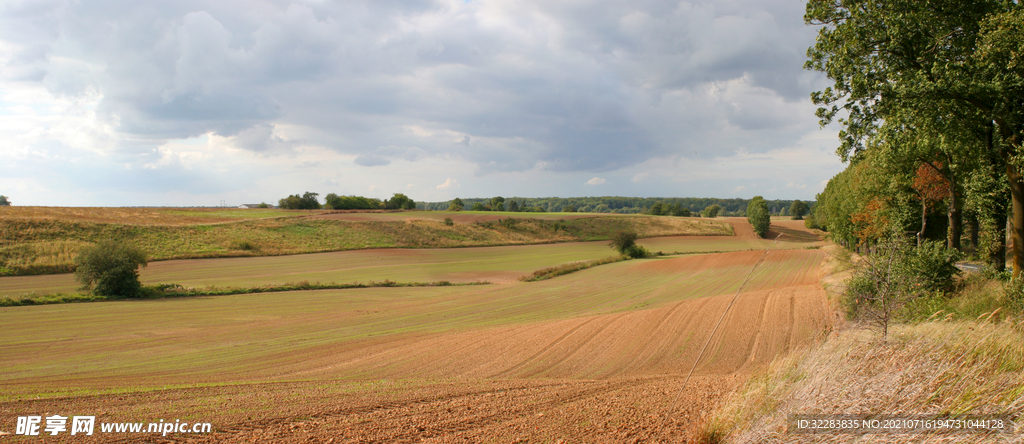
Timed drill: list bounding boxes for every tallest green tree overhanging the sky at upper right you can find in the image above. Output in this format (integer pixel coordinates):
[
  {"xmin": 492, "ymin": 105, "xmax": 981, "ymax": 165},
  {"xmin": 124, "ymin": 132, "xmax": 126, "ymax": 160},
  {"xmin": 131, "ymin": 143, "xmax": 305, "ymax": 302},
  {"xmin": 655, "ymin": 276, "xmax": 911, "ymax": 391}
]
[{"xmin": 805, "ymin": 0, "xmax": 1024, "ymax": 276}]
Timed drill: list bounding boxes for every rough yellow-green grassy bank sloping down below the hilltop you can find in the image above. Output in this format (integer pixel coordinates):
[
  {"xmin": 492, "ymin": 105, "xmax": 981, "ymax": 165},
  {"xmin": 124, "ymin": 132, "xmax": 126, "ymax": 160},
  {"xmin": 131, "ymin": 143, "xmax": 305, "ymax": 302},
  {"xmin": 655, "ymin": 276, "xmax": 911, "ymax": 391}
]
[{"xmin": 0, "ymin": 216, "xmax": 732, "ymax": 276}]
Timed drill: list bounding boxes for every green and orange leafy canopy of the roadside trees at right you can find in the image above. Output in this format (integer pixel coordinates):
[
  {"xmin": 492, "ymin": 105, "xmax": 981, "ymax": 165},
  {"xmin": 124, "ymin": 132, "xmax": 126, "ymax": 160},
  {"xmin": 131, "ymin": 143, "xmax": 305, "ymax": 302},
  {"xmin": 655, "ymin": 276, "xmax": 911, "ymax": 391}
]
[{"xmin": 805, "ymin": 0, "xmax": 1024, "ymax": 275}]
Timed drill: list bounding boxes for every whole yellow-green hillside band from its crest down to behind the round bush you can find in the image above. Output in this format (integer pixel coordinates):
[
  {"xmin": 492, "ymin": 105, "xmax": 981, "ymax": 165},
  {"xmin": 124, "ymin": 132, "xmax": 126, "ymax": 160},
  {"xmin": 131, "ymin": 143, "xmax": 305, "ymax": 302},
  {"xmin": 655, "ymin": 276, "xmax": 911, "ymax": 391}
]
[{"xmin": 0, "ymin": 207, "xmax": 732, "ymax": 276}]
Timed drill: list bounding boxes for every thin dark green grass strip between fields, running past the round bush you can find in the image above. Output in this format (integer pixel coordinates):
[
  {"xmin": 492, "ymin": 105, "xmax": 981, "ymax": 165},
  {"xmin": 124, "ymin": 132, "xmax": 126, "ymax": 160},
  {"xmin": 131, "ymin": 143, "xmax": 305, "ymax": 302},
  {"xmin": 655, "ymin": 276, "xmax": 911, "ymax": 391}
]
[{"xmin": 0, "ymin": 280, "xmax": 490, "ymax": 307}]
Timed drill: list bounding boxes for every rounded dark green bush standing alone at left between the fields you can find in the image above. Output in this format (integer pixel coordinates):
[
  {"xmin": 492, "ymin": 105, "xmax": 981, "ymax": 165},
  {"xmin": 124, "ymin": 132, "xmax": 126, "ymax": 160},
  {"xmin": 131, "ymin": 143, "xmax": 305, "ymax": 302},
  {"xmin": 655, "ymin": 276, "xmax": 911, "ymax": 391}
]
[{"xmin": 75, "ymin": 240, "xmax": 146, "ymax": 298}]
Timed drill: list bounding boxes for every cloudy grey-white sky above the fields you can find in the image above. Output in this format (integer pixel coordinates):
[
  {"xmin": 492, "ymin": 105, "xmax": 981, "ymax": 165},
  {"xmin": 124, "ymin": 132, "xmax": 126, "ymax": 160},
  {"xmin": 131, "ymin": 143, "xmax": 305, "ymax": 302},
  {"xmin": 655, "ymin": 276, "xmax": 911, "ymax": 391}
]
[{"xmin": 0, "ymin": 0, "xmax": 844, "ymax": 207}]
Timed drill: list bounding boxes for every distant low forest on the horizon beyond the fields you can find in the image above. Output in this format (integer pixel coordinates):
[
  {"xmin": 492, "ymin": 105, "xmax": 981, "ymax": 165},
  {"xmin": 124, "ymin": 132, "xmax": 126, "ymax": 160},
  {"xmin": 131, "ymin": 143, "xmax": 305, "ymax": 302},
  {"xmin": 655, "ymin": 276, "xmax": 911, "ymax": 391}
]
[{"xmin": 416, "ymin": 196, "xmax": 814, "ymax": 216}]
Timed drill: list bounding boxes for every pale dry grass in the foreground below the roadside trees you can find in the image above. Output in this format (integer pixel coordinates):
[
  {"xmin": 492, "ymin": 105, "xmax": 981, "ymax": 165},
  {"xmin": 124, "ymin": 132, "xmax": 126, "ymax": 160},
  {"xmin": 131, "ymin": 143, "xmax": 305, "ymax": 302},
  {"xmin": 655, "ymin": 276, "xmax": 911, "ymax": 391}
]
[{"xmin": 709, "ymin": 319, "xmax": 1024, "ymax": 443}]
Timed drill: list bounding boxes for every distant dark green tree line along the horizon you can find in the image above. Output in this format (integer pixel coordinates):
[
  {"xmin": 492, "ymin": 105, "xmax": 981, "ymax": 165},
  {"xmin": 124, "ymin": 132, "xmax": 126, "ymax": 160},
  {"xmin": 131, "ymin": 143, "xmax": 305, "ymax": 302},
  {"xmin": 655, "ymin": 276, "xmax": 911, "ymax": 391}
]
[{"xmin": 417, "ymin": 196, "xmax": 814, "ymax": 217}]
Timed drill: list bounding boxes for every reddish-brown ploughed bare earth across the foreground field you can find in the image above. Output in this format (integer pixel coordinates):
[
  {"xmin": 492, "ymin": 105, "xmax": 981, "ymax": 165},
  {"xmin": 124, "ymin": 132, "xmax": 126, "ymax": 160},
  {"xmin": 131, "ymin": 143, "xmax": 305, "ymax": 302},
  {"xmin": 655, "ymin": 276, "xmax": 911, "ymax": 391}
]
[{"xmin": 0, "ymin": 220, "xmax": 830, "ymax": 443}]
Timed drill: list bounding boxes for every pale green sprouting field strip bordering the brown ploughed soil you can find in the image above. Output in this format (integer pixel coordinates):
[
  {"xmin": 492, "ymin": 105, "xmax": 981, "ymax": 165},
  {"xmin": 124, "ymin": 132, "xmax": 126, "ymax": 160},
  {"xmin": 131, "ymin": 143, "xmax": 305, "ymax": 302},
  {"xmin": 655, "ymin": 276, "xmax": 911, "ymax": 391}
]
[{"xmin": 0, "ymin": 247, "xmax": 821, "ymax": 400}]
